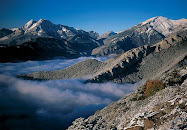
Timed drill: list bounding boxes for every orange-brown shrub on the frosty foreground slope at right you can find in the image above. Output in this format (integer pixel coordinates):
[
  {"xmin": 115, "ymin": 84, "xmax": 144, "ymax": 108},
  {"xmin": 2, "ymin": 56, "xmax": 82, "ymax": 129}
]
[{"xmin": 145, "ymin": 80, "xmax": 164, "ymax": 97}]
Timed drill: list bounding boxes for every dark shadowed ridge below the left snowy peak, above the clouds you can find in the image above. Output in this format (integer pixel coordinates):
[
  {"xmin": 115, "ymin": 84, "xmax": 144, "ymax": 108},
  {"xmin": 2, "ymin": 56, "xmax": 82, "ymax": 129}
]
[{"xmin": 0, "ymin": 37, "xmax": 77, "ymax": 62}]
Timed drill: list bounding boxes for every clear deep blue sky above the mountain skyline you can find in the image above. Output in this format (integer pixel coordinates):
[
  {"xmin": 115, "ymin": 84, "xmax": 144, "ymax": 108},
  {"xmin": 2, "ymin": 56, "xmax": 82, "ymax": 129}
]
[{"xmin": 0, "ymin": 0, "xmax": 187, "ymax": 33}]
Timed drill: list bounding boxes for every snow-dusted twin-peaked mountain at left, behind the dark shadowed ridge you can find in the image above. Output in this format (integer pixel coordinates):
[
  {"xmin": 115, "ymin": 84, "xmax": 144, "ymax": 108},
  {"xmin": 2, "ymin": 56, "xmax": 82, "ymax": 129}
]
[{"xmin": 0, "ymin": 19, "xmax": 95, "ymax": 45}]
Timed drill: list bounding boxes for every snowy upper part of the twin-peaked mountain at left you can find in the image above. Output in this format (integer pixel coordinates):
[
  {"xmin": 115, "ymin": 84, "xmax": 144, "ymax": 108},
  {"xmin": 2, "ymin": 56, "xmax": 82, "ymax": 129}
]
[{"xmin": 16, "ymin": 19, "xmax": 92, "ymax": 39}]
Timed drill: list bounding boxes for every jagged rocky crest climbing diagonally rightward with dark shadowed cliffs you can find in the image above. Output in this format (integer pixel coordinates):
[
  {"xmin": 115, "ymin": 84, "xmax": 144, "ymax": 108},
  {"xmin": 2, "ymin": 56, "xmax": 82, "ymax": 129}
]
[{"xmin": 91, "ymin": 35, "xmax": 186, "ymax": 83}]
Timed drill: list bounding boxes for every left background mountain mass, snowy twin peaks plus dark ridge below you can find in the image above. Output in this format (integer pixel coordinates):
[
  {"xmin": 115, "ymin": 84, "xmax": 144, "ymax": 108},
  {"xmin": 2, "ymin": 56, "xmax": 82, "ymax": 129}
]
[{"xmin": 0, "ymin": 19, "xmax": 102, "ymax": 62}]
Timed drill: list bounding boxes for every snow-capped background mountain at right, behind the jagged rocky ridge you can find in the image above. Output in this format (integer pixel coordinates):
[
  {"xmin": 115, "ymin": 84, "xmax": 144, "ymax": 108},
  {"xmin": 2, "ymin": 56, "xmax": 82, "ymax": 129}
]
[{"xmin": 92, "ymin": 17, "xmax": 187, "ymax": 56}]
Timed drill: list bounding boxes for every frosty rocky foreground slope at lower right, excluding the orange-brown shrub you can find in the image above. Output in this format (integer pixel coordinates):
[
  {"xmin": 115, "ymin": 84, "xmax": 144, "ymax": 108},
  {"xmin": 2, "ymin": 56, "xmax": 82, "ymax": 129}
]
[{"xmin": 68, "ymin": 65, "xmax": 187, "ymax": 130}]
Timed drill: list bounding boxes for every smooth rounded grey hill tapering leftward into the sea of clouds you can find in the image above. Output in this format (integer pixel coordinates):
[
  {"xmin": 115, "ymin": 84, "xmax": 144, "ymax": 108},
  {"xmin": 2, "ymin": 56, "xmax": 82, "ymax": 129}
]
[{"xmin": 18, "ymin": 59, "xmax": 105, "ymax": 80}]
